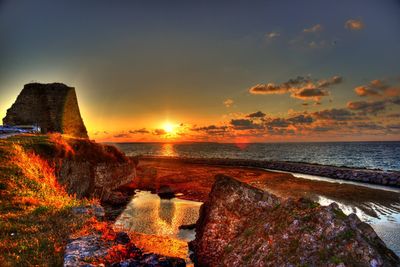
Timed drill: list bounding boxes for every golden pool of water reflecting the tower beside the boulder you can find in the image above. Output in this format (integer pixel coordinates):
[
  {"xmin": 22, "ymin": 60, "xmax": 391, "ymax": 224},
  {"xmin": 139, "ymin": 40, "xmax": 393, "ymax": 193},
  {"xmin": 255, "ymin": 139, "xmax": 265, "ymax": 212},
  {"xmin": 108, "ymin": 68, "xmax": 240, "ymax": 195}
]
[{"xmin": 115, "ymin": 192, "xmax": 201, "ymax": 241}]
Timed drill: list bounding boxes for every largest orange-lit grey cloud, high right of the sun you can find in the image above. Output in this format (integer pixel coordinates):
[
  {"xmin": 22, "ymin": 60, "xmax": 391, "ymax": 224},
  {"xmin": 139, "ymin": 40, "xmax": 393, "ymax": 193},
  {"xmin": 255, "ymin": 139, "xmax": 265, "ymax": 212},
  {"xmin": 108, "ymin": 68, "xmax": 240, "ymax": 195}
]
[{"xmin": 249, "ymin": 76, "xmax": 343, "ymax": 101}]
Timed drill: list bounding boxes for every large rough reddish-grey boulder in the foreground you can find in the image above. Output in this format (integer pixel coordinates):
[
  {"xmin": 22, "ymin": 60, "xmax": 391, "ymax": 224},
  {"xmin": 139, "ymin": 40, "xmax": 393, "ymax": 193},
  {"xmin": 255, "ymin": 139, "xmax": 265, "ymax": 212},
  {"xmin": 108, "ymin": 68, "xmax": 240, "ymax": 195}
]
[{"xmin": 190, "ymin": 175, "xmax": 400, "ymax": 266}]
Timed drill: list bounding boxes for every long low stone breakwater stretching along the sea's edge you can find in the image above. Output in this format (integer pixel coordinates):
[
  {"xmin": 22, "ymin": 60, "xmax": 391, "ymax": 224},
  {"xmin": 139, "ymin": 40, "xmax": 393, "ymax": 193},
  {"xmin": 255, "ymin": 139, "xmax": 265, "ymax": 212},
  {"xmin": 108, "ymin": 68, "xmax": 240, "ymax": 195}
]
[{"xmin": 140, "ymin": 156, "xmax": 400, "ymax": 188}]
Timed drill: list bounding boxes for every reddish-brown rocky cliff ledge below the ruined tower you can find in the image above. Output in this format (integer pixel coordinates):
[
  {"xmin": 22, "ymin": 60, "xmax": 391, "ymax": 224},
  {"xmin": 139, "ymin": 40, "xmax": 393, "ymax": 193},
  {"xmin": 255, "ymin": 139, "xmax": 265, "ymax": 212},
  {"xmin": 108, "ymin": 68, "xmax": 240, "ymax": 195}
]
[{"xmin": 25, "ymin": 134, "xmax": 137, "ymax": 201}]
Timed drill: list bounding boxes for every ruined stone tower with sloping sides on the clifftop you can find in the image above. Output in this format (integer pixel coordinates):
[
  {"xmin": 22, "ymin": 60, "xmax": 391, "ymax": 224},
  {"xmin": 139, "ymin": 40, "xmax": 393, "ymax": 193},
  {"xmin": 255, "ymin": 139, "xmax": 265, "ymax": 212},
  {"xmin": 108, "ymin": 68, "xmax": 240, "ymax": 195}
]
[{"xmin": 3, "ymin": 83, "xmax": 88, "ymax": 138}]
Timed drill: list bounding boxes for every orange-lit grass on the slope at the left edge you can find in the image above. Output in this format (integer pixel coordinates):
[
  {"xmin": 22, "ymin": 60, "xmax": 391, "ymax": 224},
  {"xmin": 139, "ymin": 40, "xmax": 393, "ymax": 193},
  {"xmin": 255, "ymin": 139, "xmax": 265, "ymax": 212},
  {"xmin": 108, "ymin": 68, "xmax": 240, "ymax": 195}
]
[{"xmin": 0, "ymin": 136, "xmax": 97, "ymax": 266}]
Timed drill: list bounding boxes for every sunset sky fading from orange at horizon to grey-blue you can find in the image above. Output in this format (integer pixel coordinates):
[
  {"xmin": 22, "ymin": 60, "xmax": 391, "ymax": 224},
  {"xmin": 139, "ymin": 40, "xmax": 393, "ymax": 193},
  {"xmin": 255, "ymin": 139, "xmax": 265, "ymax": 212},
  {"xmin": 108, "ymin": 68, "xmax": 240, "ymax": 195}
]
[{"xmin": 0, "ymin": 0, "xmax": 400, "ymax": 142}]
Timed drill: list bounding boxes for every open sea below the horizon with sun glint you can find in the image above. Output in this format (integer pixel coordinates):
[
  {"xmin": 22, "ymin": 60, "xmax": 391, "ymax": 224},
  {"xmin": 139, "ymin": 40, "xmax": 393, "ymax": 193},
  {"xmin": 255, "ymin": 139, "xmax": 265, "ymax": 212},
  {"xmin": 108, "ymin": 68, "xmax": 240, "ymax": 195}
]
[{"xmin": 110, "ymin": 141, "xmax": 400, "ymax": 171}]
